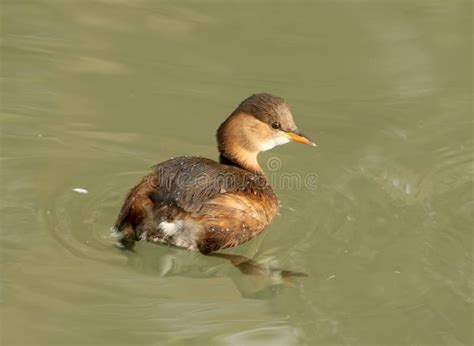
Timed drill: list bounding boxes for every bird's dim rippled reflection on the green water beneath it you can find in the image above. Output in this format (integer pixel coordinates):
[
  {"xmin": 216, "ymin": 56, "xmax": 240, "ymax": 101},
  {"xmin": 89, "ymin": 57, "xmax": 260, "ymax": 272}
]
[{"xmin": 123, "ymin": 243, "xmax": 307, "ymax": 299}]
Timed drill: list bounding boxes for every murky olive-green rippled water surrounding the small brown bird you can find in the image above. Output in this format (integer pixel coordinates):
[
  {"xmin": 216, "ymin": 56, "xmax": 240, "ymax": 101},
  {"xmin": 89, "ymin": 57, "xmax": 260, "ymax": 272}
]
[{"xmin": 0, "ymin": 0, "xmax": 474, "ymax": 345}]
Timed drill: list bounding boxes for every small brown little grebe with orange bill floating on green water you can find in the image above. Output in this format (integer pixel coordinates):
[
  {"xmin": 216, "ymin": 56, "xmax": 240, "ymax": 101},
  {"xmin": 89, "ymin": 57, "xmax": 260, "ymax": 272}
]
[{"xmin": 115, "ymin": 93, "xmax": 315, "ymax": 254}]
